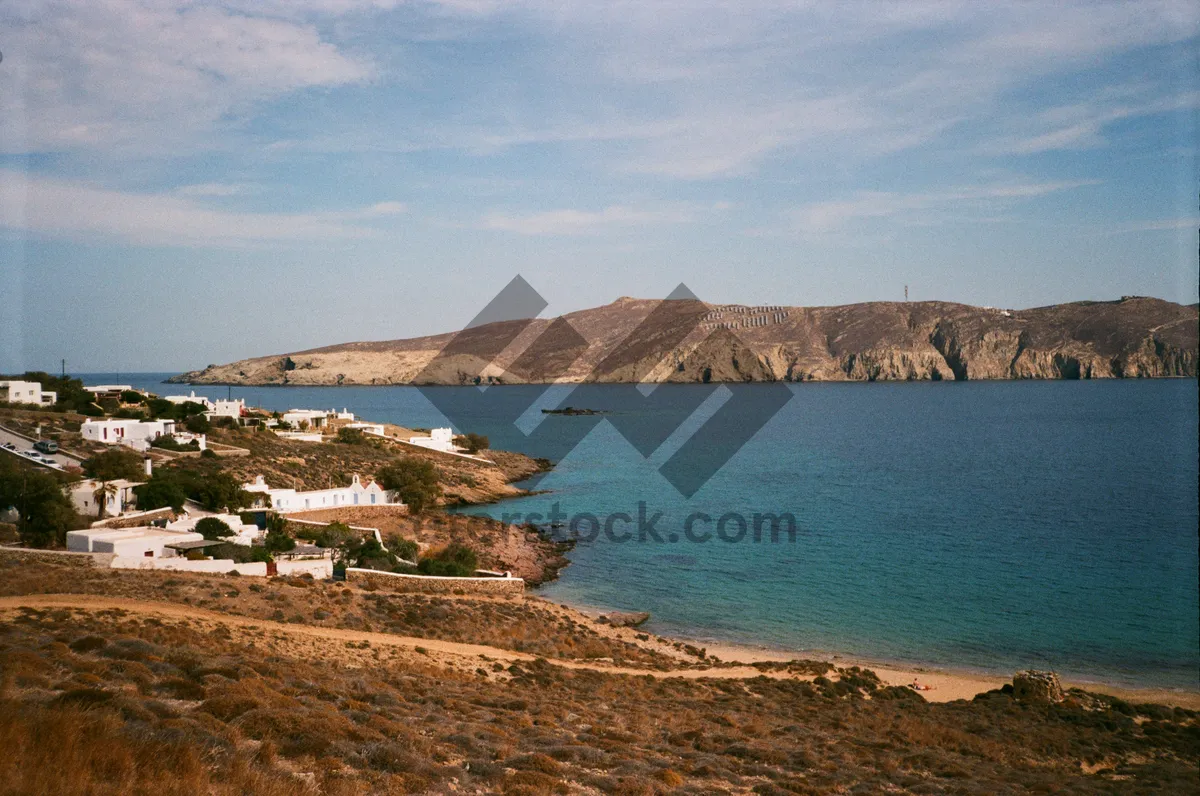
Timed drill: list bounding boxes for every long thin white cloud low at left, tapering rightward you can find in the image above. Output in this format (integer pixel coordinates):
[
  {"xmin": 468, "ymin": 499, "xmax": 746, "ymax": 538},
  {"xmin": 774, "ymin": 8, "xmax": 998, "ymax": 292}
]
[{"xmin": 0, "ymin": 169, "xmax": 404, "ymax": 246}]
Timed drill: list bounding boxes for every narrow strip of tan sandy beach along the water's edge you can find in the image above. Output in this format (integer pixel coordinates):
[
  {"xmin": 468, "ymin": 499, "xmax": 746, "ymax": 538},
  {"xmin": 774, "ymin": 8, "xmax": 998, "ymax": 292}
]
[{"xmin": 549, "ymin": 603, "xmax": 1200, "ymax": 710}]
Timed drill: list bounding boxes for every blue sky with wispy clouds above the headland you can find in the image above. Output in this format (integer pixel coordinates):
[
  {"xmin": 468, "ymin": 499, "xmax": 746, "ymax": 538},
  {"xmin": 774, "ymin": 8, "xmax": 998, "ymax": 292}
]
[{"xmin": 0, "ymin": 0, "xmax": 1200, "ymax": 372}]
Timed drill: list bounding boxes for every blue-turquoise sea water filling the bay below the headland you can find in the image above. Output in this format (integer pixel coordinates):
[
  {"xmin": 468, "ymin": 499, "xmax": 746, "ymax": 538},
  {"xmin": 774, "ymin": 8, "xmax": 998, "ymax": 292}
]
[{"xmin": 96, "ymin": 376, "xmax": 1200, "ymax": 689}]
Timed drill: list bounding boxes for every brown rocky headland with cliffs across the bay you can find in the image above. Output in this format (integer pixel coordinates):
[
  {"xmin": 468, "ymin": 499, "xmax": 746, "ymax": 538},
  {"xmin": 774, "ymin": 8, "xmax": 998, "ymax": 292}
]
[{"xmin": 172, "ymin": 298, "xmax": 1198, "ymax": 384}]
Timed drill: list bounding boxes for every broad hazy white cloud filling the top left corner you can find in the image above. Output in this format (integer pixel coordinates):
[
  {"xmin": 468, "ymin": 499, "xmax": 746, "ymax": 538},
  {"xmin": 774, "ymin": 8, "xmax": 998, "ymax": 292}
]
[{"xmin": 0, "ymin": 0, "xmax": 373, "ymax": 156}]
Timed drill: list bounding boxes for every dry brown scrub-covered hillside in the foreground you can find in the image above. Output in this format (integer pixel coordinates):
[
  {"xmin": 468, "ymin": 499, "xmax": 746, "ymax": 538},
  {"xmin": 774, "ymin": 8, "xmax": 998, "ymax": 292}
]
[{"xmin": 0, "ymin": 559, "xmax": 1200, "ymax": 794}]
